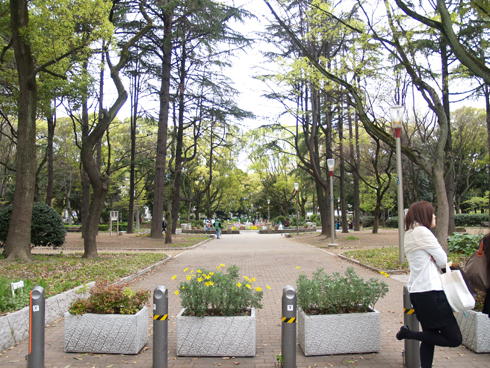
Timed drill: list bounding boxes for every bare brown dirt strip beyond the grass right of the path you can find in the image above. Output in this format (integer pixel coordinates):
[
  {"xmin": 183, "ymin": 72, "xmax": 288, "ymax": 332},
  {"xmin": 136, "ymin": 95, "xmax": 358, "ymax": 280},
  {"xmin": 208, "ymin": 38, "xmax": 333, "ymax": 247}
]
[{"xmin": 291, "ymin": 227, "xmax": 488, "ymax": 253}]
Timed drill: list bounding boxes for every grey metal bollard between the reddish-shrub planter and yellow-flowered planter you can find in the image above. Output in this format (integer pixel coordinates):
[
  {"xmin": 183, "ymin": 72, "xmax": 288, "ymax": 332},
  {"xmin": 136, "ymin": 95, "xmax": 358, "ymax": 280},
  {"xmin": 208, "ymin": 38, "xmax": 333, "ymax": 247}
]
[{"xmin": 152, "ymin": 285, "xmax": 168, "ymax": 368}]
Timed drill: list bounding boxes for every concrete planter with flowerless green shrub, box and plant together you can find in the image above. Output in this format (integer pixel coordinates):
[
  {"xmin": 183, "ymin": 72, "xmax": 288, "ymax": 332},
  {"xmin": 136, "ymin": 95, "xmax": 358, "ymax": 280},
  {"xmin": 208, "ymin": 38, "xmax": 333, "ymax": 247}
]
[{"xmin": 296, "ymin": 267, "xmax": 388, "ymax": 356}]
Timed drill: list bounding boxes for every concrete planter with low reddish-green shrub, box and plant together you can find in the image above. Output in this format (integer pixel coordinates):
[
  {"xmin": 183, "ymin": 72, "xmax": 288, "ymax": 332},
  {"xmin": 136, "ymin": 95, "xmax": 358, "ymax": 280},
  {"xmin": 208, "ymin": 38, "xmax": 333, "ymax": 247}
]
[{"xmin": 65, "ymin": 280, "xmax": 151, "ymax": 354}]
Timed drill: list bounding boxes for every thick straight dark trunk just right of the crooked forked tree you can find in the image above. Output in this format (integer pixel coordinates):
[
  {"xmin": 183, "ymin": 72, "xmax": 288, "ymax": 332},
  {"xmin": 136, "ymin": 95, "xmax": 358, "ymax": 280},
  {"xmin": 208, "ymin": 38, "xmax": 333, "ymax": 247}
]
[{"xmin": 150, "ymin": 13, "xmax": 173, "ymax": 239}]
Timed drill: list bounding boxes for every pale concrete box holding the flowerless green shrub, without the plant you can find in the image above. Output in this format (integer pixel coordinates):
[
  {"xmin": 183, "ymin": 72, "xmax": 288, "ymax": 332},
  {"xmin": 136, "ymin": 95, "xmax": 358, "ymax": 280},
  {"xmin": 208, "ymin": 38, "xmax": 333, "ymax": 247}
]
[{"xmin": 298, "ymin": 309, "xmax": 381, "ymax": 356}]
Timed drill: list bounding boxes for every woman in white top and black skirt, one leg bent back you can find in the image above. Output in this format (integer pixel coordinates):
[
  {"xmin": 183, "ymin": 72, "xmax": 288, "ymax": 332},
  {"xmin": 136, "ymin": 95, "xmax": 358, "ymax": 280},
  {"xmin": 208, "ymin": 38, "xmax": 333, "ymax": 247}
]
[{"xmin": 396, "ymin": 201, "xmax": 462, "ymax": 368}]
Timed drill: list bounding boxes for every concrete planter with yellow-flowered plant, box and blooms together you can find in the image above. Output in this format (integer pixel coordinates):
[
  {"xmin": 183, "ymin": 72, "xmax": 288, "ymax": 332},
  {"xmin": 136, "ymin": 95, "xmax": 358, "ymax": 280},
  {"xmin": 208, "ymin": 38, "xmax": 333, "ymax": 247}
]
[{"xmin": 176, "ymin": 264, "xmax": 263, "ymax": 356}]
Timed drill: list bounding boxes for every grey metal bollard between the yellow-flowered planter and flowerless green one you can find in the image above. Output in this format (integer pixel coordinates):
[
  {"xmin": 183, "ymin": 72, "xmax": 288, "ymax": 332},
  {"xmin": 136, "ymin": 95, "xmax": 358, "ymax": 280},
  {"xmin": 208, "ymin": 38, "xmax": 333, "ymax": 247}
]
[{"xmin": 281, "ymin": 285, "xmax": 296, "ymax": 368}]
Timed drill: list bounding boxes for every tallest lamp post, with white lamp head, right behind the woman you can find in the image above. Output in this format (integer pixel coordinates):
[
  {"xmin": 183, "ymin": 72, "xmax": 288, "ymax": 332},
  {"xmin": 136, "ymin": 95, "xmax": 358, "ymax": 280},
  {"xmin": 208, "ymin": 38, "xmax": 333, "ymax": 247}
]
[{"xmin": 390, "ymin": 106, "xmax": 405, "ymax": 264}]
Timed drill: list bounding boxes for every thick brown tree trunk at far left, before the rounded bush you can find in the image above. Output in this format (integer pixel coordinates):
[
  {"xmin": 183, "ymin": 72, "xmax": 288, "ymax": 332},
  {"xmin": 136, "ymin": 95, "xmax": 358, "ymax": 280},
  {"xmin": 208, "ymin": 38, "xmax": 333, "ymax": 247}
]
[{"xmin": 4, "ymin": 0, "xmax": 37, "ymax": 261}]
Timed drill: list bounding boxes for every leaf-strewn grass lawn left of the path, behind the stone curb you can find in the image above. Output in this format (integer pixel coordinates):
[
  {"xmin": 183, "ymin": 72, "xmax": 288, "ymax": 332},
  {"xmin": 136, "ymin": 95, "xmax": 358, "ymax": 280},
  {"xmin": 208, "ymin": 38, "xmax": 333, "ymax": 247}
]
[{"xmin": 0, "ymin": 253, "xmax": 167, "ymax": 315}]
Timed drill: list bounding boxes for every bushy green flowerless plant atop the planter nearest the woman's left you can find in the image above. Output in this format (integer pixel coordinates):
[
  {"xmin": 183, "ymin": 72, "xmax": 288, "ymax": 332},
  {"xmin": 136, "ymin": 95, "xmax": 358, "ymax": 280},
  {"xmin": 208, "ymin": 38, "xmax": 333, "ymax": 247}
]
[{"xmin": 296, "ymin": 267, "xmax": 388, "ymax": 315}]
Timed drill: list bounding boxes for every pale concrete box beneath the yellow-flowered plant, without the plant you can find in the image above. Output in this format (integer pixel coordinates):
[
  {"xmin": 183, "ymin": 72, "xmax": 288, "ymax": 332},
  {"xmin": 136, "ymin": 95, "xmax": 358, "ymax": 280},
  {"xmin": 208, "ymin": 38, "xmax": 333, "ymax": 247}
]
[{"xmin": 177, "ymin": 308, "xmax": 255, "ymax": 357}]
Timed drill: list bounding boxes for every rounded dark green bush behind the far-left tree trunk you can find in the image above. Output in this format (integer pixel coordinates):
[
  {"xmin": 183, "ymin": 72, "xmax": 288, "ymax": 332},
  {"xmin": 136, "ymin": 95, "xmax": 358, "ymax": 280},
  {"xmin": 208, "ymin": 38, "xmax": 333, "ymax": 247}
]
[{"xmin": 0, "ymin": 202, "xmax": 66, "ymax": 247}]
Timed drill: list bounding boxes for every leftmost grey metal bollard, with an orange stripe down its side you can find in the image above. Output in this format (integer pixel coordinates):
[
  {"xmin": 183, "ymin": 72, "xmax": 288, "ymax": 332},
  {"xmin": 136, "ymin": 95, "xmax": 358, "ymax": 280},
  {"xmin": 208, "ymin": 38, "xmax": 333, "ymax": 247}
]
[{"xmin": 26, "ymin": 286, "xmax": 46, "ymax": 368}]
